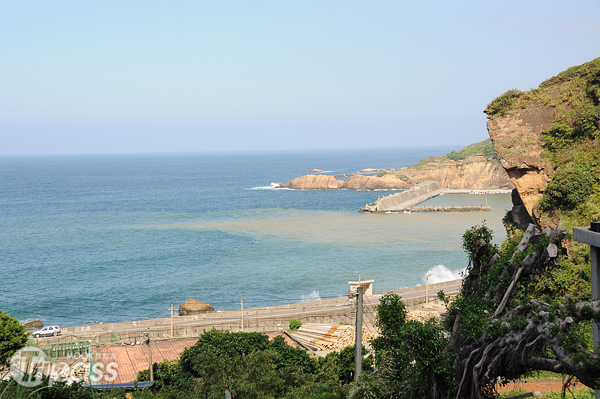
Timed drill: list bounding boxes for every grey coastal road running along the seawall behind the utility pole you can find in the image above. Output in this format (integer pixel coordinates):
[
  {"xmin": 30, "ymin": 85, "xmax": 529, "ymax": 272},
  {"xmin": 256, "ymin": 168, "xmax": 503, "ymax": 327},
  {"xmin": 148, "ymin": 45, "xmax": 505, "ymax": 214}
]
[{"xmin": 58, "ymin": 280, "xmax": 461, "ymax": 339}]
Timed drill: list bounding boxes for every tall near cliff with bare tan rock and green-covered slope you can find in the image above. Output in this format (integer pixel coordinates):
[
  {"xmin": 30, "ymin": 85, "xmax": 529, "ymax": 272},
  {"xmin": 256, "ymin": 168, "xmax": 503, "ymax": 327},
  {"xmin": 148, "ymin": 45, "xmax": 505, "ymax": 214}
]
[{"xmin": 484, "ymin": 58, "xmax": 600, "ymax": 228}]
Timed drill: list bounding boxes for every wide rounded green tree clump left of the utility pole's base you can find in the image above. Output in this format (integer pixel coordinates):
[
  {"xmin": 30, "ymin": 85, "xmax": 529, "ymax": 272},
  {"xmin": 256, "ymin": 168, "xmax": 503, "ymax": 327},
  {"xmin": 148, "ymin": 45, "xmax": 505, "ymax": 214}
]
[{"xmin": 175, "ymin": 330, "xmax": 343, "ymax": 399}]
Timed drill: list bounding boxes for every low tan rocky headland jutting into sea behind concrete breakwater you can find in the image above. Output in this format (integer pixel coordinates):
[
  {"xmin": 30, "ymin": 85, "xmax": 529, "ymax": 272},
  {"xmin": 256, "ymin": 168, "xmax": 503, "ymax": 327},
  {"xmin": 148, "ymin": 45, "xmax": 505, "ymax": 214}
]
[{"xmin": 275, "ymin": 139, "xmax": 514, "ymax": 190}]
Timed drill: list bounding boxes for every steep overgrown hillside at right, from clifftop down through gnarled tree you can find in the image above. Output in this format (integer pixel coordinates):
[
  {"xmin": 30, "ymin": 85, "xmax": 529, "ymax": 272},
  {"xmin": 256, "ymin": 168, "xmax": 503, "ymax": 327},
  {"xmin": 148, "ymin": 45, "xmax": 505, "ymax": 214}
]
[{"xmin": 438, "ymin": 58, "xmax": 600, "ymax": 398}]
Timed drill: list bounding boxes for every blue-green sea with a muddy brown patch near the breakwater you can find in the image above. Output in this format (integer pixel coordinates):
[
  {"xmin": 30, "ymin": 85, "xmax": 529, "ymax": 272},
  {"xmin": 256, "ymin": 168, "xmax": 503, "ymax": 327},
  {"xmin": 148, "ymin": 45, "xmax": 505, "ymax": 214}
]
[{"xmin": 0, "ymin": 148, "xmax": 511, "ymax": 326}]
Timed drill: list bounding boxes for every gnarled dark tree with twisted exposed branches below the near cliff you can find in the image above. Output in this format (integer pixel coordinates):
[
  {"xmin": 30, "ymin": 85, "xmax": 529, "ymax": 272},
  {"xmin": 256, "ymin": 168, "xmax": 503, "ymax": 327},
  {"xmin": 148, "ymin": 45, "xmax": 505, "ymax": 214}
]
[{"xmin": 446, "ymin": 224, "xmax": 600, "ymax": 398}]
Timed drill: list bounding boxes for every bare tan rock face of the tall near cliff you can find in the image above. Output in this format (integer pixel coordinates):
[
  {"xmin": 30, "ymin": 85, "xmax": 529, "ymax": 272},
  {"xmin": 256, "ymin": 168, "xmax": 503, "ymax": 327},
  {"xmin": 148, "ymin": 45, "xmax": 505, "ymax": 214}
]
[{"xmin": 487, "ymin": 105, "xmax": 555, "ymax": 222}]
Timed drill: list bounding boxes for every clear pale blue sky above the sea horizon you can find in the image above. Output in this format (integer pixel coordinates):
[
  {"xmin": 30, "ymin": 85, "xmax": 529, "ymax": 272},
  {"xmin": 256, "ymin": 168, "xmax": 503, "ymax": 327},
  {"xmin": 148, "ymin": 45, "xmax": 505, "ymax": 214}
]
[{"xmin": 0, "ymin": 0, "xmax": 600, "ymax": 156}]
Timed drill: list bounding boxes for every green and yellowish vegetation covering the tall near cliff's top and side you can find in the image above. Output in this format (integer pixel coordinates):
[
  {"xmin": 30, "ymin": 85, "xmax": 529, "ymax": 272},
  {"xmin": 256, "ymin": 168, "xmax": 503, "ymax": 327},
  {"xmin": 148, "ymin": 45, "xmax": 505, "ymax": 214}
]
[{"xmin": 485, "ymin": 58, "xmax": 600, "ymax": 228}]
